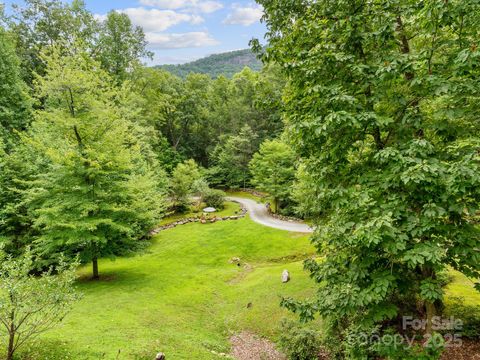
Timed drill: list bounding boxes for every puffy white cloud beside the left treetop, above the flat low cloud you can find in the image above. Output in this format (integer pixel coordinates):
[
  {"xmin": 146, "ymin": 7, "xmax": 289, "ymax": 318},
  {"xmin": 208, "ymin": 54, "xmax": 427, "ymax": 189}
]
[{"xmin": 117, "ymin": 7, "xmax": 204, "ymax": 32}]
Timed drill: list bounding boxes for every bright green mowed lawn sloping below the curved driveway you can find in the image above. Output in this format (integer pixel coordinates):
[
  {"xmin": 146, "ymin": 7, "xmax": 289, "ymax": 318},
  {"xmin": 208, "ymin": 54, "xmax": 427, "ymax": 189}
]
[{"xmin": 19, "ymin": 217, "xmax": 314, "ymax": 360}]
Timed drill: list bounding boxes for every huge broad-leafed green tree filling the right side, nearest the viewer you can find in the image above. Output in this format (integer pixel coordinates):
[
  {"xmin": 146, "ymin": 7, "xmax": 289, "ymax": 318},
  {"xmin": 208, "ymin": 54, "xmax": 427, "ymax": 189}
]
[{"xmin": 259, "ymin": 0, "xmax": 480, "ymax": 357}]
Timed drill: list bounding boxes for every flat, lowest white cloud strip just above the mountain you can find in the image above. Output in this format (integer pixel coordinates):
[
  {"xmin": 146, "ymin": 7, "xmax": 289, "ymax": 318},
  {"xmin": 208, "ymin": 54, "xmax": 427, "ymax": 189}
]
[{"xmin": 145, "ymin": 31, "xmax": 218, "ymax": 49}]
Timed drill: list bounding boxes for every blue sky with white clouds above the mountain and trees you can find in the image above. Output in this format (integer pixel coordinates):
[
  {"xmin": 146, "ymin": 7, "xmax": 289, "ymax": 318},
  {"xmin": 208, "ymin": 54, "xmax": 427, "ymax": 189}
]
[{"xmin": 0, "ymin": 0, "xmax": 265, "ymax": 64}]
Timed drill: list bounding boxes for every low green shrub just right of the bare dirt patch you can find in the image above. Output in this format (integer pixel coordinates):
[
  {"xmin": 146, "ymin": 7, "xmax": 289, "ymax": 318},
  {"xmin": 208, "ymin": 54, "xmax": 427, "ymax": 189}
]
[{"xmin": 279, "ymin": 321, "xmax": 320, "ymax": 360}]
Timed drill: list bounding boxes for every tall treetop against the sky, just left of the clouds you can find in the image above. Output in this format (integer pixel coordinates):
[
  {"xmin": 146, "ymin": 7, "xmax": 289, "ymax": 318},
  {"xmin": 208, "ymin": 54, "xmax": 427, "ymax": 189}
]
[{"xmin": 97, "ymin": 11, "xmax": 153, "ymax": 83}]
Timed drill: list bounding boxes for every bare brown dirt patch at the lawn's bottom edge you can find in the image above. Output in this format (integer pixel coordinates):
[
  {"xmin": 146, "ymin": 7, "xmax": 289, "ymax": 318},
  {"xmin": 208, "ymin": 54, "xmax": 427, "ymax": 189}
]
[{"xmin": 230, "ymin": 332, "xmax": 287, "ymax": 360}]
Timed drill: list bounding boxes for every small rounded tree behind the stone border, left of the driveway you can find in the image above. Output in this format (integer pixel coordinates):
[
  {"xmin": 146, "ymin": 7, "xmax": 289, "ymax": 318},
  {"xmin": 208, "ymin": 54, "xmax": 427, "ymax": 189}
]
[{"xmin": 170, "ymin": 159, "xmax": 202, "ymax": 211}]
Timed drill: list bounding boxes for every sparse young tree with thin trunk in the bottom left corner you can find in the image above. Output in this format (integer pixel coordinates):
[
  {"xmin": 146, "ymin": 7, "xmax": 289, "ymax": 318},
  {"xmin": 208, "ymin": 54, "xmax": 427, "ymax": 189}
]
[{"xmin": 0, "ymin": 250, "xmax": 79, "ymax": 360}]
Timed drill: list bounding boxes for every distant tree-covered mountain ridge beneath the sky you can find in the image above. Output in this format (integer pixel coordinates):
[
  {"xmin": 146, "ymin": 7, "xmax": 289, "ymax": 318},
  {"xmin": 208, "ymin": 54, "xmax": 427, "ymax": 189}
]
[{"xmin": 156, "ymin": 49, "xmax": 262, "ymax": 78}]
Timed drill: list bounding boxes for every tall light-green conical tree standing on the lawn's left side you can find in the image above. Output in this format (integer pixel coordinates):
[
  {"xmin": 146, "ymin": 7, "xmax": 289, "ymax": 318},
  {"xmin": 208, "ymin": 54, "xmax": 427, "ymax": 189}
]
[{"xmin": 25, "ymin": 47, "xmax": 165, "ymax": 279}]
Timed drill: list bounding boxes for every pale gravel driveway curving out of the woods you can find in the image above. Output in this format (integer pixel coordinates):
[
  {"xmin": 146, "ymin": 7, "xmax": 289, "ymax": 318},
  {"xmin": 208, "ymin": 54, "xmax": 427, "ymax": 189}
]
[{"xmin": 227, "ymin": 196, "xmax": 313, "ymax": 233}]
